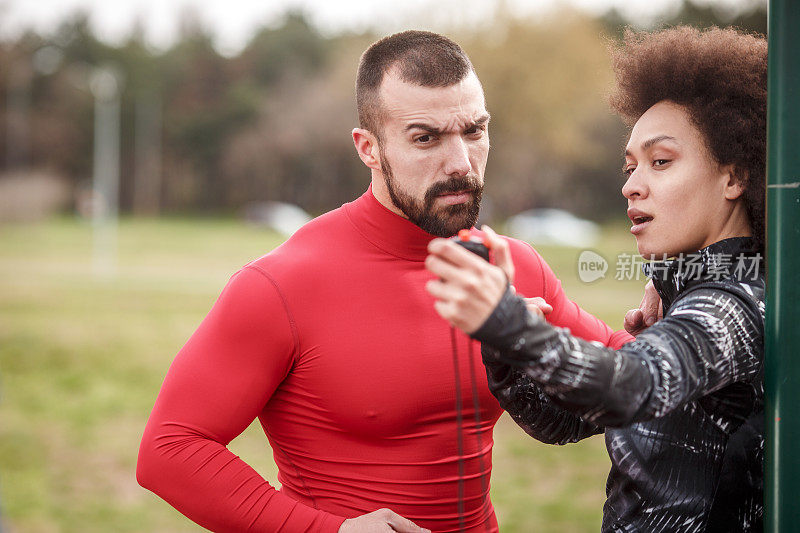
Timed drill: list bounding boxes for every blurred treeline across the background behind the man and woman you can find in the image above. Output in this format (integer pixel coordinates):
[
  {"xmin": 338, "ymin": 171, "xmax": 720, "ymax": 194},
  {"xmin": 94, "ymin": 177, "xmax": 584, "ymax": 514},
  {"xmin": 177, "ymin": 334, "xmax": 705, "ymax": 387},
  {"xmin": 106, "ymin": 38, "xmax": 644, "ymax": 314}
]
[{"xmin": 0, "ymin": 0, "xmax": 766, "ymax": 219}]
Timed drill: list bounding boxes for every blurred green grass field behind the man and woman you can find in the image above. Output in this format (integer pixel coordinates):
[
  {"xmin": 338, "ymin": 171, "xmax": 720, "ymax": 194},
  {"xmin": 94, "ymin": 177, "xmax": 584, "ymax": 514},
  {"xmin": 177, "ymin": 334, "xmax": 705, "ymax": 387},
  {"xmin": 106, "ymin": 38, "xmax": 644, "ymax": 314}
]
[{"xmin": 0, "ymin": 214, "xmax": 643, "ymax": 533}]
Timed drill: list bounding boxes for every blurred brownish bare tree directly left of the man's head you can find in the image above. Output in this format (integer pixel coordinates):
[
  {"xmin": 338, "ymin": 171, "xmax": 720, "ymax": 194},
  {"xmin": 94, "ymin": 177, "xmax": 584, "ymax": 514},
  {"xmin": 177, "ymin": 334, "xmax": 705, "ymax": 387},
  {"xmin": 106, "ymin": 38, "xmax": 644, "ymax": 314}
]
[{"xmin": 216, "ymin": 31, "xmax": 374, "ymax": 213}]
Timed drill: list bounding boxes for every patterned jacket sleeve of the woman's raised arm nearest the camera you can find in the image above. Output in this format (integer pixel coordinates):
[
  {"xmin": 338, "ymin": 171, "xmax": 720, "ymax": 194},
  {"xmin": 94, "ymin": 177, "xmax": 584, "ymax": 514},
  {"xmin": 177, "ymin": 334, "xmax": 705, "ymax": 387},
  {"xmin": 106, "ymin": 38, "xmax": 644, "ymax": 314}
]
[{"xmin": 473, "ymin": 286, "xmax": 764, "ymax": 426}]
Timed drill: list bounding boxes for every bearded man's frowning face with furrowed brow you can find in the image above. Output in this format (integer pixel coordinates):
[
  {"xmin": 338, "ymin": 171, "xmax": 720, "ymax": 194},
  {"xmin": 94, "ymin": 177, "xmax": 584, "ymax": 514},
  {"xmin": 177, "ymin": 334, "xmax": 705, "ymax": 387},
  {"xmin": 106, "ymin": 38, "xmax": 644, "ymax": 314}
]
[{"xmin": 376, "ymin": 70, "xmax": 489, "ymax": 237}]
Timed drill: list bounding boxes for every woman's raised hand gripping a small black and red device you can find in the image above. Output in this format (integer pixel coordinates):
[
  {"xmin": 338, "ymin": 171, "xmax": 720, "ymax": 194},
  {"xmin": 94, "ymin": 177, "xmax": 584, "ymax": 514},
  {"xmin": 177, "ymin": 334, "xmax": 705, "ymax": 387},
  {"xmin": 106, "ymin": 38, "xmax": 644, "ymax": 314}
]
[{"xmin": 425, "ymin": 226, "xmax": 532, "ymax": 334}]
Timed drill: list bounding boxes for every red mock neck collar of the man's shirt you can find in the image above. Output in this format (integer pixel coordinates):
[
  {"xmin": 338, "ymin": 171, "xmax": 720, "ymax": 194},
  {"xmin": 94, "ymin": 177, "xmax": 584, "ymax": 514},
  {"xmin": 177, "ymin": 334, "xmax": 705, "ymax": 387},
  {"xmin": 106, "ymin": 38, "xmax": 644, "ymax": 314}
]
[{"xmin": 344, "ymin": 185, "xmax": 435, "ymax": 261}]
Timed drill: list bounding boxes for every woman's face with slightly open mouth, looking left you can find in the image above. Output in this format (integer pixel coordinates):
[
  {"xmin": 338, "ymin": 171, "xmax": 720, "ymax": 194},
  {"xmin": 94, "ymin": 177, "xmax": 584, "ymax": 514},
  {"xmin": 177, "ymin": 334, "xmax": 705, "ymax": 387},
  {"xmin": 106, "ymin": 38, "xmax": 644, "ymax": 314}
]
[{"xmin": 622, "ymin": 100, "xmax": 750, "ymax": 258}]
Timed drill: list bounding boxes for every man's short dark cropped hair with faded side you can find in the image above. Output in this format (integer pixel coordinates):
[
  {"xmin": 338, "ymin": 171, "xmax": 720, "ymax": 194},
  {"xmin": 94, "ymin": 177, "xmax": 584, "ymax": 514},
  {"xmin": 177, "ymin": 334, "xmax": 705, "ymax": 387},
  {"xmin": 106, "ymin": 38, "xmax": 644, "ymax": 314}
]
[{"xmin": 356, "ymin": 30, "xmax": 473, "ymax": 138}]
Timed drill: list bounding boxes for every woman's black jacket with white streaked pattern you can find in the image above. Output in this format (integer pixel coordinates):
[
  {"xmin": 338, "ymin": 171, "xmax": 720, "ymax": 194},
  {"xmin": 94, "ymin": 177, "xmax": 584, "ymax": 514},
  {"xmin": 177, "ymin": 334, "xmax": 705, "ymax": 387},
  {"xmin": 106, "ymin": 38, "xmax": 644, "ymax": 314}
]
[{"xmin": 473, "ymin": 238, "xmax": 764, "ymax": 532}]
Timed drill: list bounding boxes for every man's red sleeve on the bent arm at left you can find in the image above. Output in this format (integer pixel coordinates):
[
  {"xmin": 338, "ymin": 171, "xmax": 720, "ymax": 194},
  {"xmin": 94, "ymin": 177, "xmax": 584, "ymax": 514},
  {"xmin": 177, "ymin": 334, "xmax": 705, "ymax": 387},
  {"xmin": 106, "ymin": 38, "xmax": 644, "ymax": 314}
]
[{"xmin": 136, "ymin": 267, "xmax": 344, "ymax": 533}]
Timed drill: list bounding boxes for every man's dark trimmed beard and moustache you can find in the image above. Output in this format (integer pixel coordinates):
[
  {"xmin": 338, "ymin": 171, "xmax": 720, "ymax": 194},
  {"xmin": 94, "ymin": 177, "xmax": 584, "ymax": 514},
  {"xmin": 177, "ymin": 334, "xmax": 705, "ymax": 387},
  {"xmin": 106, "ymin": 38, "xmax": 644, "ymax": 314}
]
[{"xmin": 381, "ymin": 150, "xmax": 483, "ymax": 237}]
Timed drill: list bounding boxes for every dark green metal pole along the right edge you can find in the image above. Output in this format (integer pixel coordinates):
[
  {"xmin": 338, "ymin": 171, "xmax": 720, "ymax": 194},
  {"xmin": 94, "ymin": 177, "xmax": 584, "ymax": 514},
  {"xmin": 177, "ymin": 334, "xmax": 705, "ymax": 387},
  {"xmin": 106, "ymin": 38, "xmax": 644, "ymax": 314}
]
[{"xmin": 764, "ymin": 0, "xmax": 800, "ymax": 533}]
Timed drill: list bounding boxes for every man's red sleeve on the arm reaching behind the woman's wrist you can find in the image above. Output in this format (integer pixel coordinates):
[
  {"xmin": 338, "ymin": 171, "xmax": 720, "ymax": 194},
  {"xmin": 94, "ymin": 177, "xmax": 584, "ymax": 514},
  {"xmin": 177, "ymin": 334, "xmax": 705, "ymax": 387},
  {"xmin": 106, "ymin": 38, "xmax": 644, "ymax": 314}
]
[{"xmin": 509, "ymin": 241, "xmax": 633, "ymax": 350}]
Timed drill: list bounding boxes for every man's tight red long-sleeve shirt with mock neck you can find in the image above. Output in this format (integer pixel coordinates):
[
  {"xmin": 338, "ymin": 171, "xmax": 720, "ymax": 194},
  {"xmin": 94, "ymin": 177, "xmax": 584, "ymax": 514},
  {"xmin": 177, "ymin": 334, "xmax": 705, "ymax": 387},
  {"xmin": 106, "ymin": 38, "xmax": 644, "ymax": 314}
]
[{"xmin": 137, "ymin": 185, "xmax": 629, "ymax": 532}]
